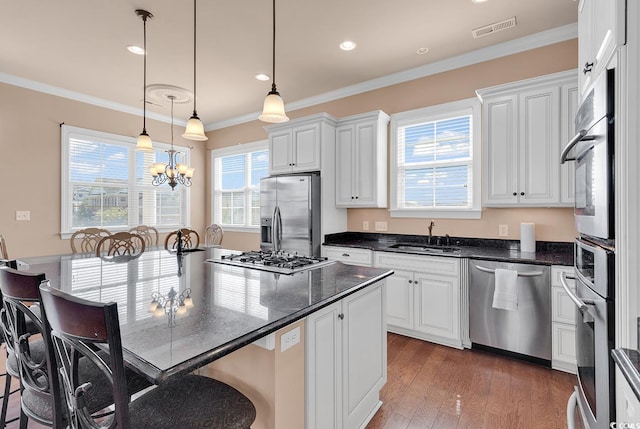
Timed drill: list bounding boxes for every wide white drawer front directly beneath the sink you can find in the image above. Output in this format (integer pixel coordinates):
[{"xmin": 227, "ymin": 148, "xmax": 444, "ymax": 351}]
[{"xmin": 374, "ymin": 252, "xmax": 460, "ymax": 276}]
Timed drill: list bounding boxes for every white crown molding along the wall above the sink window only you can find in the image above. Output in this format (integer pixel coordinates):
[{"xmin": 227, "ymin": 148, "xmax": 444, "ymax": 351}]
[{"xmin": 205, "ymin": 22, "xmax": 578, "ymax": 131}]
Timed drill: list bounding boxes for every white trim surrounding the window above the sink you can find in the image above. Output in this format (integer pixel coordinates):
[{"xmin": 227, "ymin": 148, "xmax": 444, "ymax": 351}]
[{"xmin": 389, "ymin": 97, "xmax": 482, "ymax": 219}]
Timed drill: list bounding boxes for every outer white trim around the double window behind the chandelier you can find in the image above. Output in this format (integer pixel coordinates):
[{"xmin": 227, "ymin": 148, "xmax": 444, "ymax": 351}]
[{"xmin": 60, "ymin": 125, "xmax": 191, "ymax": 240}]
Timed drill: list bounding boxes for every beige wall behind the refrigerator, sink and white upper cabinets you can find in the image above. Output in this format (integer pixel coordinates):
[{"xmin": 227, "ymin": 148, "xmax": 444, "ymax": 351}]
[{"xmin": 206, "ymin": 40, "xmax": 578, "ymax": 250}]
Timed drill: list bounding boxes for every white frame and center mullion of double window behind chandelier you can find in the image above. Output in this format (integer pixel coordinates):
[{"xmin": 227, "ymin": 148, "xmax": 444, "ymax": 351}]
[{"xmin": 60, "ymin": 124, "xmax": 191, "ymax": 239}]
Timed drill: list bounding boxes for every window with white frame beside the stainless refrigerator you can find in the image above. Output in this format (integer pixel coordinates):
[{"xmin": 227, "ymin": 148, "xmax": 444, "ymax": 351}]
[{"xmin": 211, "ymin": 140, "xmax": 269, "ymax": 230}]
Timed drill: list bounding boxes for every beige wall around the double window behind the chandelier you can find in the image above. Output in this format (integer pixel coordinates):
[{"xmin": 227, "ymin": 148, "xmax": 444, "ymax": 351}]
[{"xmin": 0, "ymin": 84, "xmax": 205, "ymax": 258}]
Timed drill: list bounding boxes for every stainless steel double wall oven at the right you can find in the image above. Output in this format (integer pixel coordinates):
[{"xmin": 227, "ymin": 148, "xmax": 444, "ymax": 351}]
[{"xmin": 561, "ymin": 70, "xmax": 615, "ymax": 429}]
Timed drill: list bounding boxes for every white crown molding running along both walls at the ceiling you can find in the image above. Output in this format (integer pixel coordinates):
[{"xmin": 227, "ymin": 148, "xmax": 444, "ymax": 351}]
[{"xmin": 0, "ymin": 23, "xmax": 578, "ymax": 131}]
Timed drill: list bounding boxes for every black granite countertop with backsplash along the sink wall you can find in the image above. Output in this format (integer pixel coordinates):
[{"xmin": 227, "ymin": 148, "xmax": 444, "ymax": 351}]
[{"xmin": 323, "ymin": 232, "xmax": 573, "ymax": 266}]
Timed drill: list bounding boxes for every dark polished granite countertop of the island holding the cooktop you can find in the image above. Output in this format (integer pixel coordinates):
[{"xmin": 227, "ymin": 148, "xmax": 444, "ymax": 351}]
[{"xmin": 21, "ymin": 248, "xmax": 393, "ymax": 383}]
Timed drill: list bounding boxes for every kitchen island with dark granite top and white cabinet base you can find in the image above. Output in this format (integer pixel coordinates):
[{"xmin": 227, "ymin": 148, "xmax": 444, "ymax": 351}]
[{"xmin": 21, "ymin": 248, "xmax": 392, "ymax": 427}]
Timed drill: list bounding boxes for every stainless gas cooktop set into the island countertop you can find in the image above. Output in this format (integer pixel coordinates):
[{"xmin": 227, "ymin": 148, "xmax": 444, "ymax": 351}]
[{"xmin": 208, "ymin": 250, "xmax": 335, "ymax": 274}]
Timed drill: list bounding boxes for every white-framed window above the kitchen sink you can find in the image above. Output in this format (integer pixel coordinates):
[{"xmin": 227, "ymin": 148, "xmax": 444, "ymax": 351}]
[{"xmin": 390, "ymin": 99, "xmax": 480, "ymax": 219}]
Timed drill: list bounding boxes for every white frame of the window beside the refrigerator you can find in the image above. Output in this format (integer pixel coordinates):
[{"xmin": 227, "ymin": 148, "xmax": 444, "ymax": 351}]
[{"xmin": 210, "ymin": 140, "xmax": 271, "ymax": 233}]
